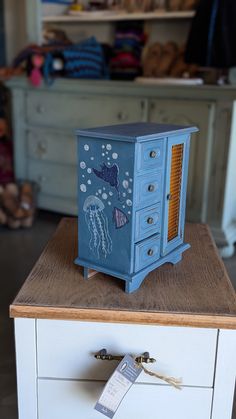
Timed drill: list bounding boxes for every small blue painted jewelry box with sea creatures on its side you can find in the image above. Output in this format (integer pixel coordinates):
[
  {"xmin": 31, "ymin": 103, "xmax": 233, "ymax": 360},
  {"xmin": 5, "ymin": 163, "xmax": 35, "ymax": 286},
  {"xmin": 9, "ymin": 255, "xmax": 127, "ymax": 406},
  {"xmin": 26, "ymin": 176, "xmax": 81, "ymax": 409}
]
[{"xmin": 75, "ymin": 123, "xmax": 197, "ymax": 293}]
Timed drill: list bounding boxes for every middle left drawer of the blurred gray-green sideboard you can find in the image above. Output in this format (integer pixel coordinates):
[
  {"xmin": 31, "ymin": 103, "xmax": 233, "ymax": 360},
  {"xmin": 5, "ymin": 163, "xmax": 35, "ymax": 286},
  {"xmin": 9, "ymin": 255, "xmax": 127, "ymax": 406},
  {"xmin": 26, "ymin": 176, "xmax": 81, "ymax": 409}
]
[{"xmin": 27, "ymin": 129, "xmax": 77, "ymax": 165}]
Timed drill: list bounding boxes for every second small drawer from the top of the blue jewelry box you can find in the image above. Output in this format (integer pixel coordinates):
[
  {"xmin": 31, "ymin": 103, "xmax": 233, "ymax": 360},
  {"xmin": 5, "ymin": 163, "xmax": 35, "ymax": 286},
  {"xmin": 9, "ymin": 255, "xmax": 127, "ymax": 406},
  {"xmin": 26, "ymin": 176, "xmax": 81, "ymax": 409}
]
[{"xmin": 135, "ymin": 172, "xmax": 162, "ymax": 207}]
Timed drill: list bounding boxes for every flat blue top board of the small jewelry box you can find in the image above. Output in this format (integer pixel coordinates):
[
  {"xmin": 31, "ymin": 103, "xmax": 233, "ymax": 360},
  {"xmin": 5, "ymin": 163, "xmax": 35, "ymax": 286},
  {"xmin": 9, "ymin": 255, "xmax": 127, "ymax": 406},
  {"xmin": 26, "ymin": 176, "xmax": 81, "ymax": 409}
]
[{"xmin": 76, "ymin": 122, "xmax": 198, "ymax": 142}]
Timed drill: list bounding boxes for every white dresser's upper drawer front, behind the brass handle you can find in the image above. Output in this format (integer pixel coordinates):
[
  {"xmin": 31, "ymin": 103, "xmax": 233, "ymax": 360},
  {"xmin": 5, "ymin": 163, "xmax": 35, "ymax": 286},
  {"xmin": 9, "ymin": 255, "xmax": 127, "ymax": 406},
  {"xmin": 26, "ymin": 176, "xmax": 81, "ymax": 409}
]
[{"xmin": 37, "ymin": 320, "xmax": 217, "ymax": 387}]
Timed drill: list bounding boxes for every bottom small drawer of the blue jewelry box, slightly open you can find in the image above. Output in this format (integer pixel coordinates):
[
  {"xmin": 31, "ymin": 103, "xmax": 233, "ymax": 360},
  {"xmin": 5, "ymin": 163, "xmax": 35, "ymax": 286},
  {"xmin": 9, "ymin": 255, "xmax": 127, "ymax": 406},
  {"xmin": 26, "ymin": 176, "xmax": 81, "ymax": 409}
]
[{"xmin": 134, "ymin": 235, "xmax": 160, "ymax": 272}]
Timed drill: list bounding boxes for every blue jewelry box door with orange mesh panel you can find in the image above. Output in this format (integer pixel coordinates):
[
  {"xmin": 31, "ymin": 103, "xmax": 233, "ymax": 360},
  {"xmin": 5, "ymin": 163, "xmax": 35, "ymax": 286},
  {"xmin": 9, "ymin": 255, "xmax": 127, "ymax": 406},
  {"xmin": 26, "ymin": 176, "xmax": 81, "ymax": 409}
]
[{"xmin": 162, "ymin": 135, "xmax": 190, "ymax": 256}]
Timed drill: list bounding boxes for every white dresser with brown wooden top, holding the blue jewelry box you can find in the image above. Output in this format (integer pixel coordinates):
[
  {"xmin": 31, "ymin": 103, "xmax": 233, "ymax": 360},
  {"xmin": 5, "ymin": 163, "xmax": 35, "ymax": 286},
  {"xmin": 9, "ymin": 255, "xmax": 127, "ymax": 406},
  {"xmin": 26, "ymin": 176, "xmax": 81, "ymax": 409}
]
[{"xmin": 10, "ymin": 219, "xmax": 236, "ymax": 419}]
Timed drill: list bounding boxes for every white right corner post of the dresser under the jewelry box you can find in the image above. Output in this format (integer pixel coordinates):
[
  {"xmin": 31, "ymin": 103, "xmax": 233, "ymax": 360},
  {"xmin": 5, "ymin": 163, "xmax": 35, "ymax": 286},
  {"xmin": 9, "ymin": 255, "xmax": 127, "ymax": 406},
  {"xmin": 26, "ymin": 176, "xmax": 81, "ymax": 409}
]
[{"xmin": 211, "ymin": 330, "xmax": 236, "ymax": 419}]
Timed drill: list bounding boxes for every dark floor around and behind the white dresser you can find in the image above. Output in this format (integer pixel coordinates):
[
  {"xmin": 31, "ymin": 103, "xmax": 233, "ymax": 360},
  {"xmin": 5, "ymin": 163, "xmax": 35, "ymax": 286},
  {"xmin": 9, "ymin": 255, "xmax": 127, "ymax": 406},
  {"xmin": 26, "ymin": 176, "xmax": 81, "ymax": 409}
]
[{"xmin": 0, "ymin": 212, "xmax": 236, "ymax": 419}]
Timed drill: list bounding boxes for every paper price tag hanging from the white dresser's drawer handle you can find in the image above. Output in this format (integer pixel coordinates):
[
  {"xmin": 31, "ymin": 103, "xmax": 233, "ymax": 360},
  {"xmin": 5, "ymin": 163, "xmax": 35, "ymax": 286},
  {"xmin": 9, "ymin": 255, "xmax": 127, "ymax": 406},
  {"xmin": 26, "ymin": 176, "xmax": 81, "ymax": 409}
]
[{"xmin": 95, "ymin": 355, "xmax": 142, "ymax": 418}]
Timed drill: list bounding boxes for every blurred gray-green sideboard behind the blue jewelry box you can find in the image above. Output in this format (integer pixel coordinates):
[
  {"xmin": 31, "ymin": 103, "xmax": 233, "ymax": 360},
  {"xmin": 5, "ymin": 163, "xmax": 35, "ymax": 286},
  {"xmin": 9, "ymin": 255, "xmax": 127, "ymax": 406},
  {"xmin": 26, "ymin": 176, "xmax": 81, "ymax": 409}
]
[{"xmin": 8, "ymin": 77, "xmax": 236, "ymax": 256}]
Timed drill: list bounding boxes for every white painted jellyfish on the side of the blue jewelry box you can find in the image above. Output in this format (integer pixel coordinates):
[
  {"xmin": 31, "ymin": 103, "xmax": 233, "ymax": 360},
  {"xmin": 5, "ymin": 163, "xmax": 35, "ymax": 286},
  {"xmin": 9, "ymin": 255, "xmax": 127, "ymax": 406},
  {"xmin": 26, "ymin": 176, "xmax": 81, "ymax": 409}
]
[{"xmin": 83, "ymin": 195, "xmax": 112, "ymax": 259}]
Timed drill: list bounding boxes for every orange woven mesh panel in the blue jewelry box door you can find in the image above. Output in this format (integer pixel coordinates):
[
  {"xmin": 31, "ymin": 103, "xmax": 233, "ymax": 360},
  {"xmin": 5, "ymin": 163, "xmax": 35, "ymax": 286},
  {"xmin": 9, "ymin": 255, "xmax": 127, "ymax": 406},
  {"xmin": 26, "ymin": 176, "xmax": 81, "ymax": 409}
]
[{"xmin": 168, "ymin": 144, "xmax": 184, "ymax": 242}]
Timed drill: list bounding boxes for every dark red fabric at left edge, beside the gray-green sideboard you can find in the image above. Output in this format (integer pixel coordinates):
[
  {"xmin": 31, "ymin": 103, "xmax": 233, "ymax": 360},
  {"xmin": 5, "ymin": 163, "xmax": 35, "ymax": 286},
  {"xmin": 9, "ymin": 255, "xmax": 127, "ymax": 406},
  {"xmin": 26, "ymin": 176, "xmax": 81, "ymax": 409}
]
[{"xmin": 0, "ymin": 140, "xmax": 14, "ymax": 185}]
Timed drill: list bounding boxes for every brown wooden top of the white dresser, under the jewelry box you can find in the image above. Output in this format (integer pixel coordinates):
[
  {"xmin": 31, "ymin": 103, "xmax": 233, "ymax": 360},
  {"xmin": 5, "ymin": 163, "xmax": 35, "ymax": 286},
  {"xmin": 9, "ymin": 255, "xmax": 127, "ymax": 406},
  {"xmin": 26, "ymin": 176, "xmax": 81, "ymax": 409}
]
[{"xmin": 10, "ymin": 218, "xmax": 236, "ymax": 329}]
